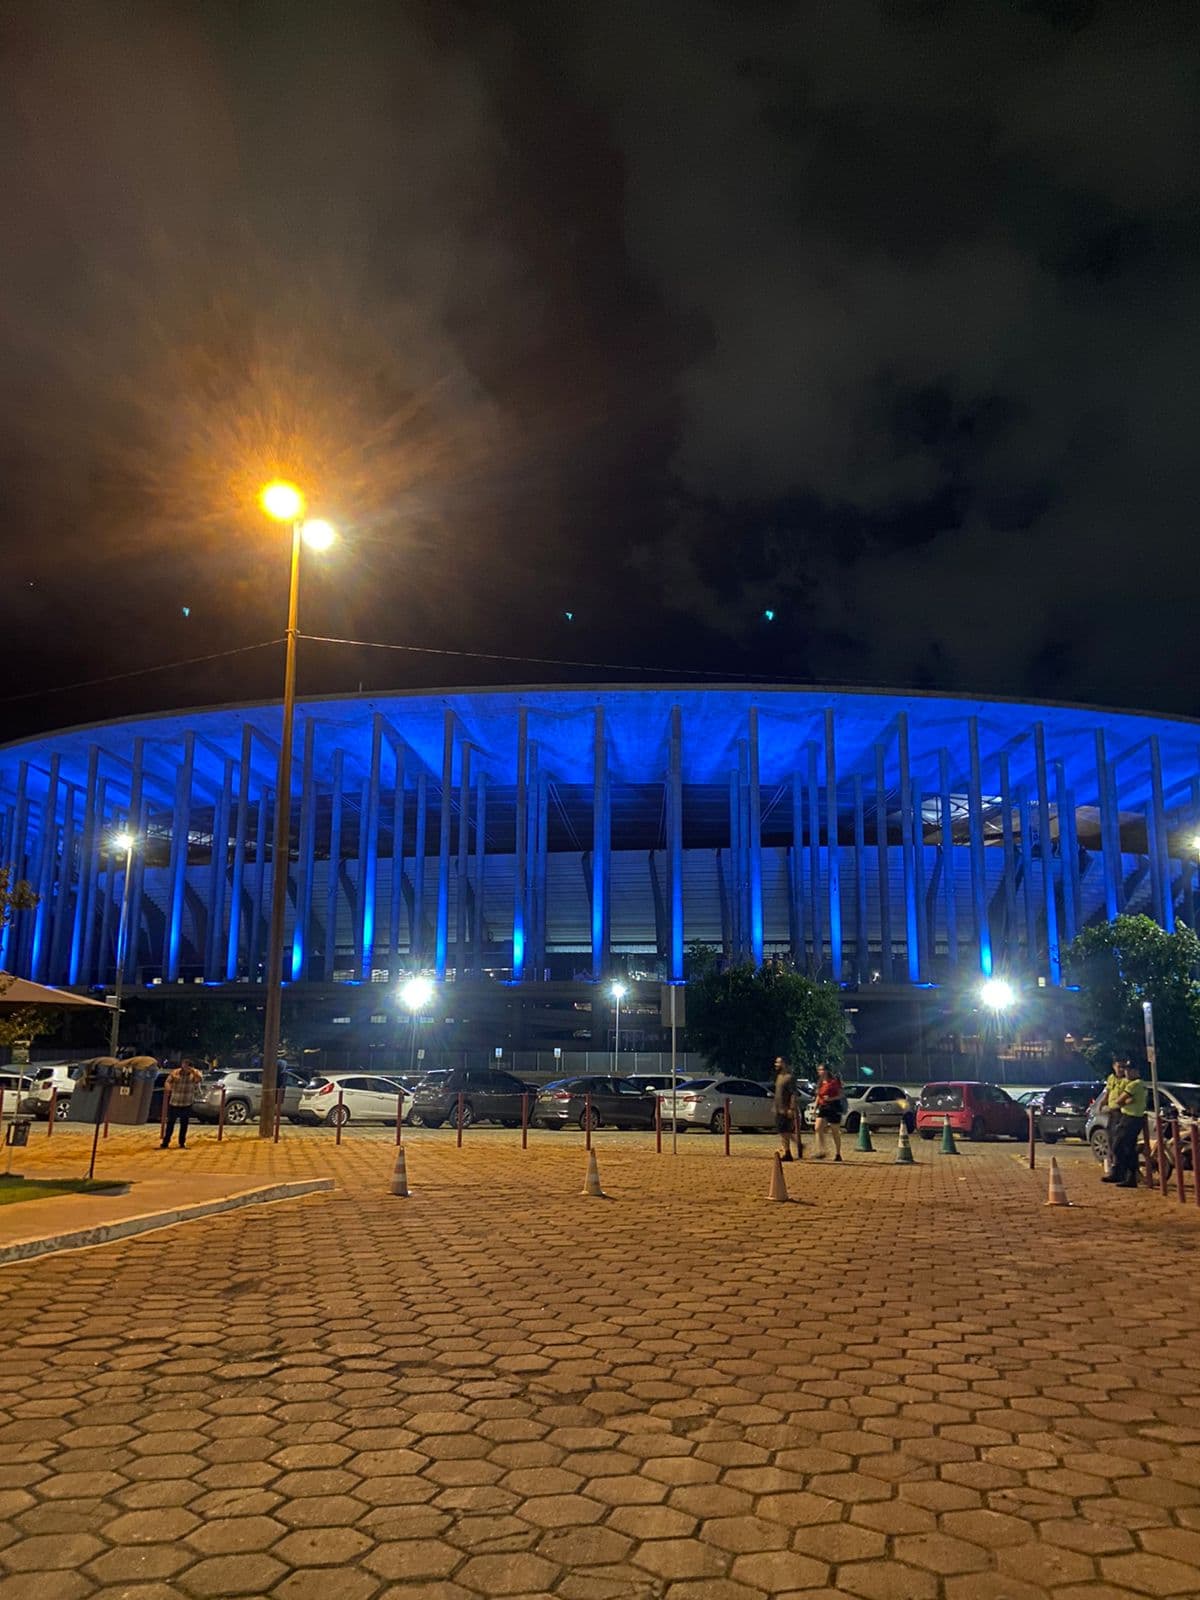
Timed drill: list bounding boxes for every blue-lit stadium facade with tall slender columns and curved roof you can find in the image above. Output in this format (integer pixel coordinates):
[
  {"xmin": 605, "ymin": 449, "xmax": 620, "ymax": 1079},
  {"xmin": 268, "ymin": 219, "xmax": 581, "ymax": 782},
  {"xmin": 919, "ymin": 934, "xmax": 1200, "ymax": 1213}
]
[{"xmin": 0, "ymin": 686, "xmax": 1200, "ymax": 984}]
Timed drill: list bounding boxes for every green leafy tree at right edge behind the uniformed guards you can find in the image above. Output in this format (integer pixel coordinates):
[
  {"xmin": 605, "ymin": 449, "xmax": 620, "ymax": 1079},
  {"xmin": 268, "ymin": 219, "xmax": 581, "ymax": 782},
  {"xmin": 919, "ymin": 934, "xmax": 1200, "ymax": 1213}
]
[{"xmin": 1064, "ymin": 917, "xmax": 1200, "ymax": 1078}]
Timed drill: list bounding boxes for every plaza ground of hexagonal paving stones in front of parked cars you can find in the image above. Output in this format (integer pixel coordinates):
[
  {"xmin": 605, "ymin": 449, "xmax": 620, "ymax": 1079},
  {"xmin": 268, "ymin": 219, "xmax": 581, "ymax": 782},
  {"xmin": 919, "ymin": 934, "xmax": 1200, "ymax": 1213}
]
[{"xmin": 0, "ymin": 1131, "xmax": 1200, "ymax": 1600}]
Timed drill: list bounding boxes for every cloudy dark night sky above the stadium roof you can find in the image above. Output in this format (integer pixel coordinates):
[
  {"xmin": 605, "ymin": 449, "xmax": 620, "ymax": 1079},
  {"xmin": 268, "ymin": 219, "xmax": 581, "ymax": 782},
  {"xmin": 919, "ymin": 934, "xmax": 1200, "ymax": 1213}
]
[{"xmin": 0, "ymin": 0, "xmax": 1200, "ymax": 738}]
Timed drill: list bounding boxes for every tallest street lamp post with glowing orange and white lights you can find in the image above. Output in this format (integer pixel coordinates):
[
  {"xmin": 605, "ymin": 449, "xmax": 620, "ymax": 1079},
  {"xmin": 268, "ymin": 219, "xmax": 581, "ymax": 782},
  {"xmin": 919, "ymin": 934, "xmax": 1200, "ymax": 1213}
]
[{"xmin": 258, "ymin": 478, "xmax": 336, "ymax": 1139}]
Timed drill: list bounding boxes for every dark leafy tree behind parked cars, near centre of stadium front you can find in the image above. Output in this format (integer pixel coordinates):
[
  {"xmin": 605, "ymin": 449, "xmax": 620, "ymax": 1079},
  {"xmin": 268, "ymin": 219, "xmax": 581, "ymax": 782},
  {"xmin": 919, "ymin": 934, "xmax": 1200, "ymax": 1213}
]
[{"xmin": 686, "ymin": 947, "xmax": 846, "ymax": 1078}]
